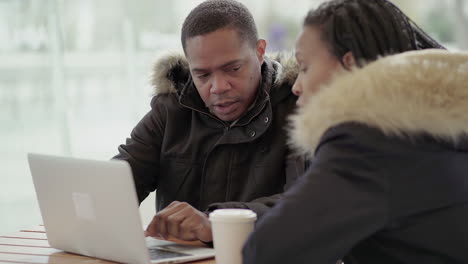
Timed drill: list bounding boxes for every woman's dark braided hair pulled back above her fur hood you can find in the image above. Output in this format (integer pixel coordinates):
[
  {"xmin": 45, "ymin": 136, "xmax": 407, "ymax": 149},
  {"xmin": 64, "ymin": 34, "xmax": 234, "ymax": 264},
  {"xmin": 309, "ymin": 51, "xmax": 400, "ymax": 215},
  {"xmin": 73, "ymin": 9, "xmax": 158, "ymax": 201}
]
[{"xmin": 304, "ymin": 0, "xmax": 444, "ymax": 66}]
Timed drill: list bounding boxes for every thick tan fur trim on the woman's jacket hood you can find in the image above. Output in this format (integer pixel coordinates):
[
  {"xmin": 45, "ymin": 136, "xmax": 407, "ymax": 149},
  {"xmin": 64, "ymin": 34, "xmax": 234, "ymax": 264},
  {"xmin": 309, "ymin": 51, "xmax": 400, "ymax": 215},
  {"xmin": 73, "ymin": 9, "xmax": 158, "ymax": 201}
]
[{"xmin": 290, "ymin": 50, "xmax": 468, "ymax": 156}]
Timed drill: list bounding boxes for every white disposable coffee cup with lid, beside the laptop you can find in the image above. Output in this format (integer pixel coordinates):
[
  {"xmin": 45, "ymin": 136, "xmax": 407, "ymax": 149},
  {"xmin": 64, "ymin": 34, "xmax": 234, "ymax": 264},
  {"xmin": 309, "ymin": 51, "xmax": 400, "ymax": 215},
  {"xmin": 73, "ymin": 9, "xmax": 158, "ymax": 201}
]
[{"xmin": 209, "ymin": 209, "xmax": 257, "ymax": 264}]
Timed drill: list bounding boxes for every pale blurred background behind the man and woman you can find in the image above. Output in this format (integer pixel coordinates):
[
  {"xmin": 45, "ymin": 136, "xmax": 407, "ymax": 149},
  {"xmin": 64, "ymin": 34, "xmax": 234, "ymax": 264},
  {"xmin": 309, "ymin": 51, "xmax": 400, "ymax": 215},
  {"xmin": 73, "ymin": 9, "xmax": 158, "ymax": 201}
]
[{"xmin": 0, "ymin": 0, "xmax": 468, "ymax": 234}]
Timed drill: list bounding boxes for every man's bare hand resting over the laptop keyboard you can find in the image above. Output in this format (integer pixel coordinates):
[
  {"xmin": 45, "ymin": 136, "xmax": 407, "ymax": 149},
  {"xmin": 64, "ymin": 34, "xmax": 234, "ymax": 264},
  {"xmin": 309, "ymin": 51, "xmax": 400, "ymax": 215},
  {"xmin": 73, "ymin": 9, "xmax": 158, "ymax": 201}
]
[{"xmin": 145, "ymin": 201, "xmax": 213, "ymax": 242}]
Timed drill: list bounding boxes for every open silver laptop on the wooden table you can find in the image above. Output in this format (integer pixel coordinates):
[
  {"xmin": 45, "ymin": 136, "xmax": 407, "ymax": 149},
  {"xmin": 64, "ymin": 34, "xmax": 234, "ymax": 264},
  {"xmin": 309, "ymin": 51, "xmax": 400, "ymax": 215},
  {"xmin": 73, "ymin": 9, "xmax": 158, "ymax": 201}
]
[{"xmin": 28, "ymin": 154, "xmax": 214, "ymax": 264}]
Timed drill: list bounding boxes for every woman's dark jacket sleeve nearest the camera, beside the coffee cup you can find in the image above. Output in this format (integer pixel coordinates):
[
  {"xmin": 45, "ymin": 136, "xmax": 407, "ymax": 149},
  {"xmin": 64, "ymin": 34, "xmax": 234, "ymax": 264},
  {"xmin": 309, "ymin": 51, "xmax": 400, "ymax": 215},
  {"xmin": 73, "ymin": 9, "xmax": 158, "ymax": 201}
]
[{"xmin": 243, "ymin": 126, "xmax": 389, "ymax": 264}]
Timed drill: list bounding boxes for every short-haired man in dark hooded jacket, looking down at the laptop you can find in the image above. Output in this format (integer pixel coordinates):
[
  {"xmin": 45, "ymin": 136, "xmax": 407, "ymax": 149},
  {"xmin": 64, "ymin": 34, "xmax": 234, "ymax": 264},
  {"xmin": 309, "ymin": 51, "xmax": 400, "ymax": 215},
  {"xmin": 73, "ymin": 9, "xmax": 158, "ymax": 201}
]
[{"xmin": 115, "ymin": 0, "xmax": 303, "ymax": 242}]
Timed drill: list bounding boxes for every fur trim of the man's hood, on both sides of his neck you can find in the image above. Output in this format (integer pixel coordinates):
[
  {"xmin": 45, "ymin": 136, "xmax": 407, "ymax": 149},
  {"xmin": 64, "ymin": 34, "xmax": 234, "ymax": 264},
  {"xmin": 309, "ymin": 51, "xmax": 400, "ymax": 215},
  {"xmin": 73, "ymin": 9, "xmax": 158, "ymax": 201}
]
[{"xmin": 151, "ymin": 53, "xmax": 298, "ymax": 94}]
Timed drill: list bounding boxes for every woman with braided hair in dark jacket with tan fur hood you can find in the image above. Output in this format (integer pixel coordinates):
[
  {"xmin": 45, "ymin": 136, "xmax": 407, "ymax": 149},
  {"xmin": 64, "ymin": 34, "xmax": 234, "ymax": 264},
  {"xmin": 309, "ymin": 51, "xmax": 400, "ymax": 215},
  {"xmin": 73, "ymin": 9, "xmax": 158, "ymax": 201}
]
[{"xmin": 243, "ymin": 0, "xmax": 468, "ymax": 264}]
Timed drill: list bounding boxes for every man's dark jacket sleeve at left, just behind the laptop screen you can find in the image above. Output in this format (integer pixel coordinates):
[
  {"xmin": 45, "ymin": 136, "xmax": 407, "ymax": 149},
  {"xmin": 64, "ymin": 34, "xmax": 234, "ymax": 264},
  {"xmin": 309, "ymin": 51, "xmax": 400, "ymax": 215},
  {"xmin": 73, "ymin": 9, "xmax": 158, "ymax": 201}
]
[{"xmin": 114, "ymin": 96, "xmax": 166, "ymax": 203}]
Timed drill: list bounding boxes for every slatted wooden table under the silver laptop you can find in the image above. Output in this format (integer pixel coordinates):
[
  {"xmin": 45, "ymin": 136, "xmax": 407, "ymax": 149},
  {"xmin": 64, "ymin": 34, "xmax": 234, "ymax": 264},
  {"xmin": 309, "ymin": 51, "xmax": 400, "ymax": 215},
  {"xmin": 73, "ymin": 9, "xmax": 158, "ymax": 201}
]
[{"xmin": 0, "ymin": 226, "xmax": 216, "ymax": 264}]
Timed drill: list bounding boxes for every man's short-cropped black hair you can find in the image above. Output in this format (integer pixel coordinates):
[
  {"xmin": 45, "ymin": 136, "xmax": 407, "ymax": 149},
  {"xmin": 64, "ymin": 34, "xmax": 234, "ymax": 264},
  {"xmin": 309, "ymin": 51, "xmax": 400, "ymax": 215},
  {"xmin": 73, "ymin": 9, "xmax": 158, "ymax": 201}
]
[{"xmin": 181, "ymin": 0, "xmax": 258, "ymax": 54}]
